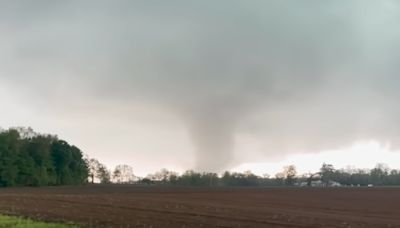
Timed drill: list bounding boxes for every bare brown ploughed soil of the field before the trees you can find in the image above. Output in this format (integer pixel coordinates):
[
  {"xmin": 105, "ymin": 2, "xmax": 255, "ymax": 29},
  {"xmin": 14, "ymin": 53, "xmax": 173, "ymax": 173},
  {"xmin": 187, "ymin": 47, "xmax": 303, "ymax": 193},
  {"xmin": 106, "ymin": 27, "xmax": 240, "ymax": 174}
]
[{"xmin": 0, "ymin": 185, "xmax": 400, "ymax": 228}]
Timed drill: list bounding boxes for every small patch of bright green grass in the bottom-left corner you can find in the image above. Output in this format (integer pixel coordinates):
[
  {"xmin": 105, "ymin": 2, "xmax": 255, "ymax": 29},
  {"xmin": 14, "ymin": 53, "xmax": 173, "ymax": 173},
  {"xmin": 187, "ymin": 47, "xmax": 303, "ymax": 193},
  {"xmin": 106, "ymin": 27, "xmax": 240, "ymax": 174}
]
[{"xmin": 0, "ymin": 215, "xmax": 78, "ymax": 228}]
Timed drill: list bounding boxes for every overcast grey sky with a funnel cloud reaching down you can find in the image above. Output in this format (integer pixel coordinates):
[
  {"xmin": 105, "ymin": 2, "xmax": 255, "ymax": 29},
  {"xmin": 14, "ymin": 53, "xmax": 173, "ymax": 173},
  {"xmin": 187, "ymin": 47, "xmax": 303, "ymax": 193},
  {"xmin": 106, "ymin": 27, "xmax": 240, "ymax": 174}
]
[{"xmin": 0, "ymin": 0, "xmax": 400, "ymax": 173}]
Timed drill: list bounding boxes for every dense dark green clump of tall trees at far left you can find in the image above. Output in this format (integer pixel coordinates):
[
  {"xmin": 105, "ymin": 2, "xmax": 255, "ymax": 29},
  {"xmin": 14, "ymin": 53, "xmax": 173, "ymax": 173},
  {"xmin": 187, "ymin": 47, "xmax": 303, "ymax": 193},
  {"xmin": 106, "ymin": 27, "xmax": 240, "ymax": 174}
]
[{"xmin": 0, "ymin": 128, "xmax": 88, "ymax": 186}]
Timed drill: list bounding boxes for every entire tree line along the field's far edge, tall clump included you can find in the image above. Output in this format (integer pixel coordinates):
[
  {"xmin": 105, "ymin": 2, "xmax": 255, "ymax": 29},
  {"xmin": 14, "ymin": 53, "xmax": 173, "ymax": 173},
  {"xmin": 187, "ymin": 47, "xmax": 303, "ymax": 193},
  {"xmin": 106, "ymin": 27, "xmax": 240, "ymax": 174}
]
[{"xmin": 0, "ymin": 128, "xmax": 400, "ymax": 186}]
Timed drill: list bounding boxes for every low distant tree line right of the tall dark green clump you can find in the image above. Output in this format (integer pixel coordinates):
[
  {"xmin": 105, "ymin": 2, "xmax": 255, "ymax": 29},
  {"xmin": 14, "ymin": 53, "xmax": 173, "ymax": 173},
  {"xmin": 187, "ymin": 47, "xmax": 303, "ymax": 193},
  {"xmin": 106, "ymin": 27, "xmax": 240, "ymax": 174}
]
[{"xmin": 90, "ymin": 162, "xmax": 400, "ymax": 187}]
